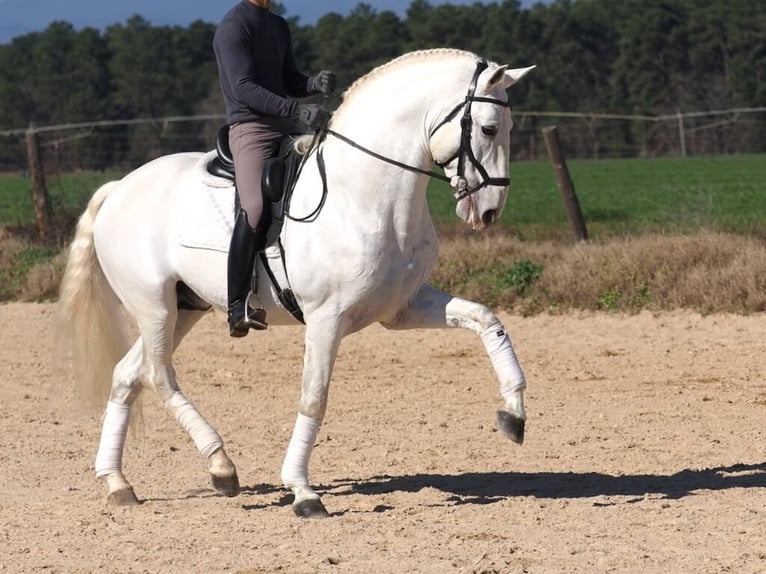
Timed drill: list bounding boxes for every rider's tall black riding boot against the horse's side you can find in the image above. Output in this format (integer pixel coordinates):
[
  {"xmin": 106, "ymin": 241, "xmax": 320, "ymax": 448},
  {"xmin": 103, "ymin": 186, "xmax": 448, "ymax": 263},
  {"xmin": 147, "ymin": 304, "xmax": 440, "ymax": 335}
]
[{"xmin": 228, "ymin": 208, "xmax": 267, "ymax": 337}]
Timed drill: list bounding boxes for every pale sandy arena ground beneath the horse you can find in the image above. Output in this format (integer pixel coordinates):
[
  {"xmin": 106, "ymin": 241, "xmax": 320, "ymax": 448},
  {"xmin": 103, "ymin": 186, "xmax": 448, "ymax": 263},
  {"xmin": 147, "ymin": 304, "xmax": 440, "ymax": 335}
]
[{"xmin": 0, "ymin": 304, "xmax": 766, "ymax": 574}]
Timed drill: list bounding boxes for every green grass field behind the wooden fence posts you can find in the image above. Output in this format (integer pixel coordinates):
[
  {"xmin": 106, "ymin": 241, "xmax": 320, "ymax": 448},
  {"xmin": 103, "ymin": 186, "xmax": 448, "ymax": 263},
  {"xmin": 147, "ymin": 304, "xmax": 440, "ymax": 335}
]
[{"xmin": 0, "ymin": 155, "xmax": 766, "ymax": 239}]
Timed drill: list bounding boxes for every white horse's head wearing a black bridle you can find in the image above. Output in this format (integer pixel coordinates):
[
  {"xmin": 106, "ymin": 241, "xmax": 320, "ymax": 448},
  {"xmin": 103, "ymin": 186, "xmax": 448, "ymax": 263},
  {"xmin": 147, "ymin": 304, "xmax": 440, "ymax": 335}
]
[{"xmin": 430, "ymin": 60, "xmax": 534, "ymax": 229}]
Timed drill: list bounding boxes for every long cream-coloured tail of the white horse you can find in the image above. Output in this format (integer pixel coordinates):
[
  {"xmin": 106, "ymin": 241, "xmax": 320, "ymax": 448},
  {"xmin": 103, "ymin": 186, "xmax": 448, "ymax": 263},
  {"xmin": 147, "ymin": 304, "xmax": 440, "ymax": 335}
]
[{"xmin": 57, "ymin": 181, "xmax": 129, "ymax": 408}]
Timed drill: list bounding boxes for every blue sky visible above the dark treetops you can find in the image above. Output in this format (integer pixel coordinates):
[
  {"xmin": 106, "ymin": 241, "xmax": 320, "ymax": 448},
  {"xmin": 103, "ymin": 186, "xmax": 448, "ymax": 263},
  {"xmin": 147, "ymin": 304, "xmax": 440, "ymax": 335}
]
[{"xmin": 0, "ymin": 0, "xmax": 533, "ymax": 44}]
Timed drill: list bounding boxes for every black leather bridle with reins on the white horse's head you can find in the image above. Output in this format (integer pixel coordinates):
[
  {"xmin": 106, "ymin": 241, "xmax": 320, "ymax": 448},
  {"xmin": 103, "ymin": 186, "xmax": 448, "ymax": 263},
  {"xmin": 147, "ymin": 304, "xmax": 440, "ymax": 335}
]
[{"xmin": 325, "ymin": 60, "xmax": 511, "ymax": 201}]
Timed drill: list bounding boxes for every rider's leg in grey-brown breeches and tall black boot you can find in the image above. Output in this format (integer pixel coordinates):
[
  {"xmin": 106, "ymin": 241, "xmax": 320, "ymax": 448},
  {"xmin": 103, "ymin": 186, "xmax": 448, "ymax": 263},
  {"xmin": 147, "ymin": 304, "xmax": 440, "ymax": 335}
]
[{"xmin": 228, "ymin": 122, "xmax": 283, "ymax": 337}]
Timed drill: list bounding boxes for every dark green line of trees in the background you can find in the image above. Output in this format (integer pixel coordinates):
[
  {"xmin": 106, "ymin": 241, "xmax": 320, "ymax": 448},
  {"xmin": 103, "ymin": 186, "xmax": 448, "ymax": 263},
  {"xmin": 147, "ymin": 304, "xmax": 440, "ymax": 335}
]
[{"xmin": 0, "ymin": 0, "xmax": 766, "ymax": 166}]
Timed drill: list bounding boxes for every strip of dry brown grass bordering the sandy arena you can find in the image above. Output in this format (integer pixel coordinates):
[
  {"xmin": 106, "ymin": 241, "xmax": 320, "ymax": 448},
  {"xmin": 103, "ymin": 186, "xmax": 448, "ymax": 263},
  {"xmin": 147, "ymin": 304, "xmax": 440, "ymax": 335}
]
[{"xmin": 0, "ymin": 225, "xmax": 766, "ymax": 315}]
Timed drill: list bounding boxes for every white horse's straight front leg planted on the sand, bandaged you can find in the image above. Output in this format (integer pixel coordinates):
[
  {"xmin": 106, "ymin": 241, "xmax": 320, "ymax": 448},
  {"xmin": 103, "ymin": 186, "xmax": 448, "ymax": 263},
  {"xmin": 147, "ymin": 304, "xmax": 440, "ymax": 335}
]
[{"xmin": 282, "ymin": 317, "xmax": 342, "ymax": 518}]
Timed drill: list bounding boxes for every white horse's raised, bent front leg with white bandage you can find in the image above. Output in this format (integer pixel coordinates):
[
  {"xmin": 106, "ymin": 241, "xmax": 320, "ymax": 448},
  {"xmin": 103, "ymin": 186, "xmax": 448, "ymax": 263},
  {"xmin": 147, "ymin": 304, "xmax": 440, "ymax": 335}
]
[{"xmin": 383, "ymin": 285, "xmax": 527, "ymax": 444}]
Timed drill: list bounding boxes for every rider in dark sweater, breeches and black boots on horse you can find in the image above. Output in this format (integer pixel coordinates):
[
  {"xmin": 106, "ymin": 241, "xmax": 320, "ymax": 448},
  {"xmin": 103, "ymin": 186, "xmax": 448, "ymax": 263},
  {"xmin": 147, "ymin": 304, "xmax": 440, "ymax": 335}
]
[{"xmin": 213, "ymin": 0, "xmax": 335, "ymax": 337}]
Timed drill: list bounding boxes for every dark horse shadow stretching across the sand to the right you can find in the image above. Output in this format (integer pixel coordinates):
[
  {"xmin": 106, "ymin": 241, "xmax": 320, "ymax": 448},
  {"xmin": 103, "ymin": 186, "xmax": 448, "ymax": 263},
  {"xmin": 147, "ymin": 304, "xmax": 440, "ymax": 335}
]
[{"xmin": 324, "ymin": 462, "xmax": 766, "ymax": 504}]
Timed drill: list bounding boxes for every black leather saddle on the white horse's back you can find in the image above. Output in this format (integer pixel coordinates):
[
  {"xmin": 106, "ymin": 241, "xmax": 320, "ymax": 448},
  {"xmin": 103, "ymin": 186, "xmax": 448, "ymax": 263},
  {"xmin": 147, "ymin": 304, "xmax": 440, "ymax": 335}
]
[{"xmin": 207, "ymin": 125, "xmax": 303, "ymax": 323}]
